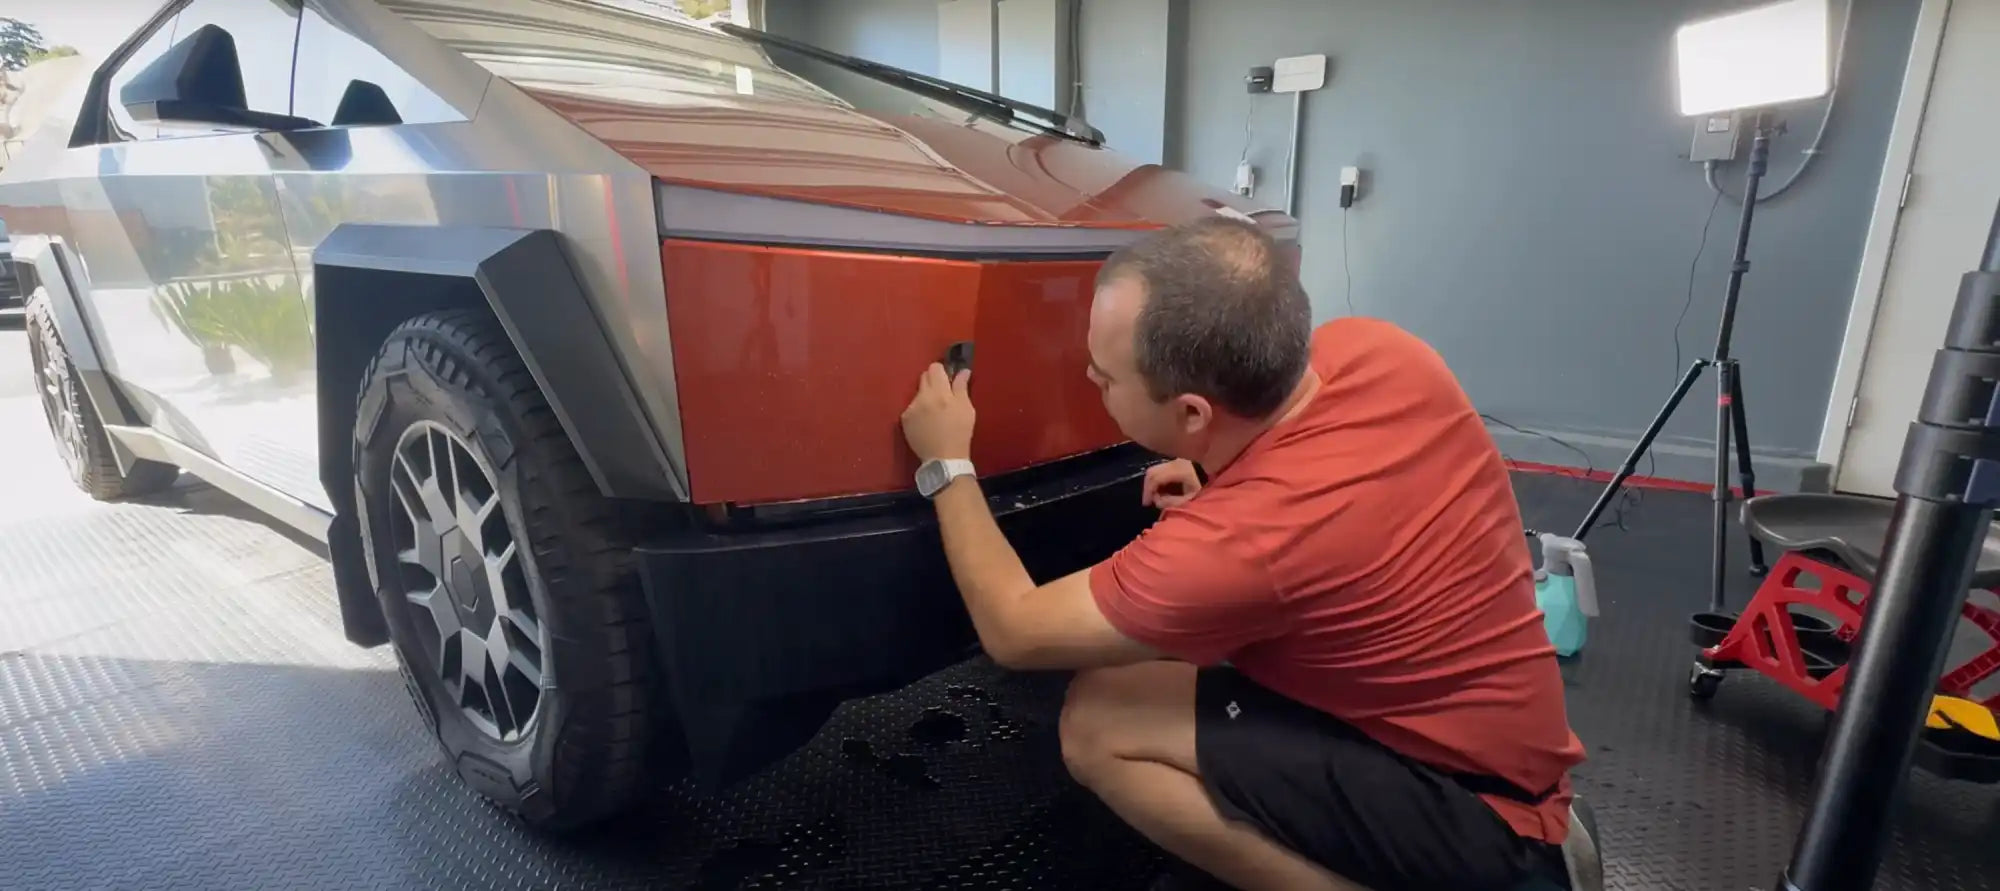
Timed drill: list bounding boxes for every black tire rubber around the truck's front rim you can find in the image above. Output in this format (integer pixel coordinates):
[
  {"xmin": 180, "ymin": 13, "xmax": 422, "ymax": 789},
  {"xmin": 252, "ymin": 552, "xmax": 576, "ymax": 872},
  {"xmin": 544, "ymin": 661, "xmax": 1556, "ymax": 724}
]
[{"xmin": 354, "ymin": 310, "xmax": 668, "ymax": 833}]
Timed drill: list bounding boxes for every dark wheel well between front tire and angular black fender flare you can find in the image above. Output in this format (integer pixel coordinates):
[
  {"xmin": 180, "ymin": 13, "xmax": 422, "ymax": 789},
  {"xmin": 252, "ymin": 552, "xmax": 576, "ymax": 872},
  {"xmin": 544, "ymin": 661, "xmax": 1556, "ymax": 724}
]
[{"xmin": 324, "ymin": 266, "xmax": 492, "ymax": 647}]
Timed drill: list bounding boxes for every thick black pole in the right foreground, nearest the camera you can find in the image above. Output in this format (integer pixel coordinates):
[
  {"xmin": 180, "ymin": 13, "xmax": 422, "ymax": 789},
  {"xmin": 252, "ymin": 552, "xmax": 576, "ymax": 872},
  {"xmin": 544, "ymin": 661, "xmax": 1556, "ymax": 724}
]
[{"xmin": 1778, "ymin": 198, "xmax": 2000, "ymax": 891}]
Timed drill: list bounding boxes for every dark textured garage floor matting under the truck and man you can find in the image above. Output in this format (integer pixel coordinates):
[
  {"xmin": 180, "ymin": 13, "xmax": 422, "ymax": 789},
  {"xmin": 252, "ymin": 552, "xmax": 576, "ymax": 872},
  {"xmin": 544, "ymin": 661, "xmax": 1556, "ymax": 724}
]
[{"xmin": 0, "ymin": 381, "xmax": 2000, "ymax": 891}]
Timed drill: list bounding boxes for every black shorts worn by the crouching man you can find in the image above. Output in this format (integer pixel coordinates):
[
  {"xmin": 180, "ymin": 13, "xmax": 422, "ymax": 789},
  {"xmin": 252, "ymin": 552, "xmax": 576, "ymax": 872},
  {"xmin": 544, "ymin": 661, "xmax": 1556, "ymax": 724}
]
[{"xmin": 1194, "ymin": 667, "xmax": 1570, "ymax": 891}]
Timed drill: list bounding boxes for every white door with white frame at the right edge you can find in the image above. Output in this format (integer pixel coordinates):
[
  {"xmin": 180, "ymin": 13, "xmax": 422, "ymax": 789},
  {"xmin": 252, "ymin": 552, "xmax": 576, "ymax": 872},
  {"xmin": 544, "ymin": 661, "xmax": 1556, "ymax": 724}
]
[{"xmin": 1836, "ymin": 0, "xmax": 2000, "ymax": 495}]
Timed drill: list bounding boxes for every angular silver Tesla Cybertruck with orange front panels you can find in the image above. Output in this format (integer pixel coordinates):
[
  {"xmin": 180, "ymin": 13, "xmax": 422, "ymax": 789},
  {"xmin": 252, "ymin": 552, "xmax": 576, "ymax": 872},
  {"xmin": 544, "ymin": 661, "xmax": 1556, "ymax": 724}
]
[{"xmin": 0, "ymin": 0, "xmax": 1296, "ymax": 831}]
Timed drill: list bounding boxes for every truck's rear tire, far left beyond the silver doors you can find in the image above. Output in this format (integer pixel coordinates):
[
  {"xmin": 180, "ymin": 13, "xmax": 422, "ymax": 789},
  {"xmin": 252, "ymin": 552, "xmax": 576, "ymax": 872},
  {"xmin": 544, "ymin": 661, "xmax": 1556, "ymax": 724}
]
[{"xmin": 24, "ymin": 288, "xmax": 180, "ymax": 501}]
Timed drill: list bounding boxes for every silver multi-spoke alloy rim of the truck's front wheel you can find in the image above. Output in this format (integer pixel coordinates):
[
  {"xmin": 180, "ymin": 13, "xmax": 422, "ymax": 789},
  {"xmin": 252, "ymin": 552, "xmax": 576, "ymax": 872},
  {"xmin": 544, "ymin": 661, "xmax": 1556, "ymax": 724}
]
[{"xmin": 388, "ymin": 422, "xmax": 548, "ymax": 741}]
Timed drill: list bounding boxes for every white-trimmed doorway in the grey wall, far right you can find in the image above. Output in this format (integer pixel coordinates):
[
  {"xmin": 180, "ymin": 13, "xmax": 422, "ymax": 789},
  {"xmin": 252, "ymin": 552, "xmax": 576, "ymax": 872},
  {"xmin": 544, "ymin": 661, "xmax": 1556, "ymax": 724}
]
[{"xmin": 1822, "ymin": 0, "xmax": 2000, "ymax": 495}]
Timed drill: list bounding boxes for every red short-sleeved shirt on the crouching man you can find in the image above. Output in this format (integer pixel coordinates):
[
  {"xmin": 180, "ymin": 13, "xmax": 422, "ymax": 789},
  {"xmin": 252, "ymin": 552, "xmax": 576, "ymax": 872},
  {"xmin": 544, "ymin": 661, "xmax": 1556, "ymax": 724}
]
[{"xmin": 1090, "ymin": 318, "xmax": 1584, "ymax": 843}]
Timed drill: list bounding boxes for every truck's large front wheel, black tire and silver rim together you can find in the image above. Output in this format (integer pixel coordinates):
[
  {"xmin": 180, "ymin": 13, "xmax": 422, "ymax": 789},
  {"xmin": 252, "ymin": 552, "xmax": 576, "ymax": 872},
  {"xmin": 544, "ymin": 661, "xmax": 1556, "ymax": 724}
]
[{"xmin": 354, "ymin": 312, "xmax": 658, "ymax": 831}]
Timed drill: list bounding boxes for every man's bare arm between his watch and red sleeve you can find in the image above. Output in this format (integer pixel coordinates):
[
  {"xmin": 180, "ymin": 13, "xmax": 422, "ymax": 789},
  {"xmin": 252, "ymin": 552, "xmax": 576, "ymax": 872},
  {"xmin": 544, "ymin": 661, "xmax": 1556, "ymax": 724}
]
[{"xmin": 936, "ymin": 475, "xmax": 1160, "ymax": 669}]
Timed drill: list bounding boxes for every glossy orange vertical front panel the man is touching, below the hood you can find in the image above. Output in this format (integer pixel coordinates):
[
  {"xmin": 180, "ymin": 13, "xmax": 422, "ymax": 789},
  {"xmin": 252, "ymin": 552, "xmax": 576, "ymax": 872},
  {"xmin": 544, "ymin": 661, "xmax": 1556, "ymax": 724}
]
[{"xmin": 662, "ymin": 240, "xmax": 1122, "ymax": 503}]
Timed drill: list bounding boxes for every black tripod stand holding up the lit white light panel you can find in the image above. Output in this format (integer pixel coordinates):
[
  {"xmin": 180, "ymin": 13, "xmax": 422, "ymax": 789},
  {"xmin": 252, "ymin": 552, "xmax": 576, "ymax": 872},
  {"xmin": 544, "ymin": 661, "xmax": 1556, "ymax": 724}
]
[{"xmin": 1570, "ymin": 110, "xmax": 1784, "ymax": 613}]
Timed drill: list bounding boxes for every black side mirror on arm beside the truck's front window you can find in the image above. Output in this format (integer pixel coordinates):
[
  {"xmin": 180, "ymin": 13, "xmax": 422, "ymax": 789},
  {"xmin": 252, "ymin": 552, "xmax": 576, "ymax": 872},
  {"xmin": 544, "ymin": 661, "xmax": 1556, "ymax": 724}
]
[{"xmin": 118, "ymin": 24, "xmax": 318, "ymax": 130}]
